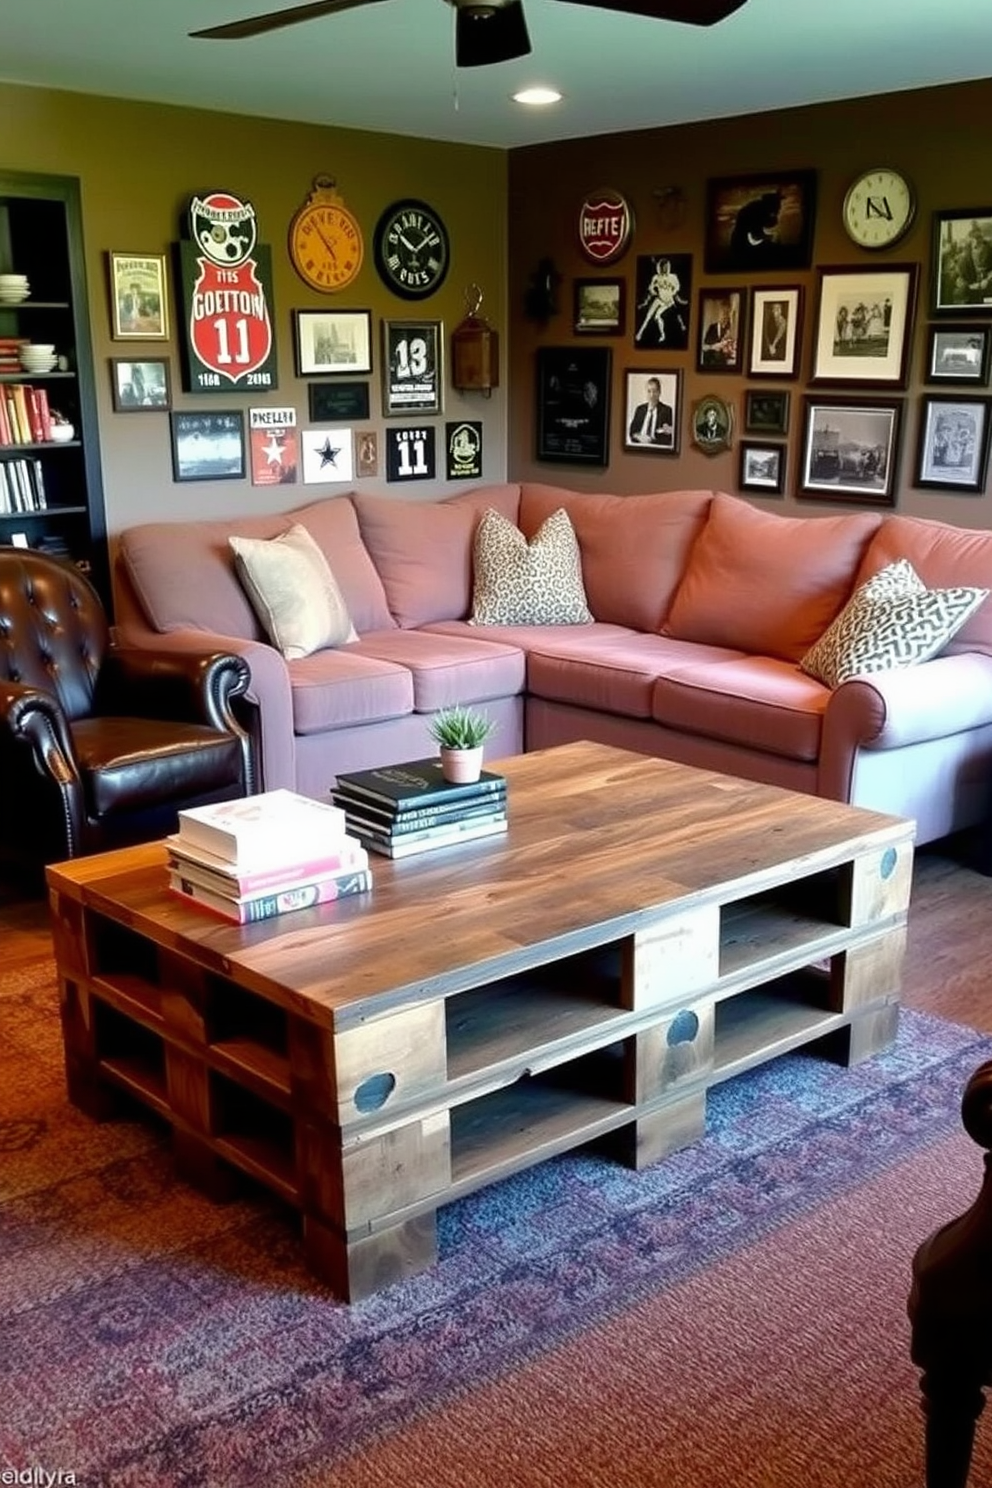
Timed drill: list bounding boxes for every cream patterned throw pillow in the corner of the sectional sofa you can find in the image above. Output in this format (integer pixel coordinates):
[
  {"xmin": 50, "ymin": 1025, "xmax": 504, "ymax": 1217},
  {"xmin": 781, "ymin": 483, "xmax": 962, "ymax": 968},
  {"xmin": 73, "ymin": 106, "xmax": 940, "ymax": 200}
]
[{"xmin": 468, "ymin": 506, "xmax": 592, "ymax": 625}]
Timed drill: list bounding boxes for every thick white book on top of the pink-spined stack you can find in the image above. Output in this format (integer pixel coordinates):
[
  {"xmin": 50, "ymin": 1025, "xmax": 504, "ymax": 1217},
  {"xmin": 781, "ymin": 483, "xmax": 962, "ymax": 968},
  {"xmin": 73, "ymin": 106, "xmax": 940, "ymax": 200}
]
[{"xmin": 178, "ymin": 790, "xmax": 347, "ymax": 872}]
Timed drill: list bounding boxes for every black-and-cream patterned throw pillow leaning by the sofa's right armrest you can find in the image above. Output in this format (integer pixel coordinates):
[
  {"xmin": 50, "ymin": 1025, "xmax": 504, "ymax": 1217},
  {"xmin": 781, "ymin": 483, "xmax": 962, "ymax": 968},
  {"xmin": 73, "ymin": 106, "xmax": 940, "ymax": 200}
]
[{"xmin": 799, "ymin": 558, "xmax": 989, "ymax": 687}]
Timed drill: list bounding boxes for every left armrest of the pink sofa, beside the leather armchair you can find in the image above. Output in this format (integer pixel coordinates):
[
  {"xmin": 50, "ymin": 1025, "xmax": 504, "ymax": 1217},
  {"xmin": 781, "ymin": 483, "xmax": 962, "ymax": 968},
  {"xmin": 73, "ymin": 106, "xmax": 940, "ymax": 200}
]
[{"xmin": 113, "ymin": 625, "xmax": 296, "ymax": 790}]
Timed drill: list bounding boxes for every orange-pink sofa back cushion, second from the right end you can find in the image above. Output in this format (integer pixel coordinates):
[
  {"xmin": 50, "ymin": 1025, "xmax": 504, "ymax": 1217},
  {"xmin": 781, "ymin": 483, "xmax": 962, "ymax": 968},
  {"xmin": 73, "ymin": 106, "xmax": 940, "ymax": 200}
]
[{"xmin": 663, "ymin": 494, "xmax": 880, "ymax": 661}]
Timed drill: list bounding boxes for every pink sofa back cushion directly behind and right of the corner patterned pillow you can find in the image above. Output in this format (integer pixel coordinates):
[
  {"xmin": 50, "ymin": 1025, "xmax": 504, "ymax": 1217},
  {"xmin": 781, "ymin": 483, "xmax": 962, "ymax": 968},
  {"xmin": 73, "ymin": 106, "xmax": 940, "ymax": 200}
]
[{"xmin": 519, "ymin": 484, "xmax": 712, "ymax": 631}]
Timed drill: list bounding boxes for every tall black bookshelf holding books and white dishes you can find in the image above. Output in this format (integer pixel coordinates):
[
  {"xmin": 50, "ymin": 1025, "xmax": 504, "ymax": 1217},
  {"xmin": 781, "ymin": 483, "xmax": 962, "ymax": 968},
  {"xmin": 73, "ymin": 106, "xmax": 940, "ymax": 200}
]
[{"xmin": 0, "ymin": 170, "xmax": 110, "ymax": 604}]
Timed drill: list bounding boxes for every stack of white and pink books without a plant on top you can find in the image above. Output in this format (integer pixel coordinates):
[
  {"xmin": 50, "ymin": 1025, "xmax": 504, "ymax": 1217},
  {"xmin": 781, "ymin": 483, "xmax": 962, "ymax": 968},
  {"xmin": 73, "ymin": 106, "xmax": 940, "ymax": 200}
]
[{"xmin": 165, "ymin": 790, "xmax": 372, "ymax": 924}]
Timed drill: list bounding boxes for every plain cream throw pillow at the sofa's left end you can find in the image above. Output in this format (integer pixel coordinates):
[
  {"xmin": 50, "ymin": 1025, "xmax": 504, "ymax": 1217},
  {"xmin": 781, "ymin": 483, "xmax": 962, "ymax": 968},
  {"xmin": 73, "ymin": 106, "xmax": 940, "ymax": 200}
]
[{"xmin": 228, "ymin": 522, "xmax": 358, "ymax": 661}]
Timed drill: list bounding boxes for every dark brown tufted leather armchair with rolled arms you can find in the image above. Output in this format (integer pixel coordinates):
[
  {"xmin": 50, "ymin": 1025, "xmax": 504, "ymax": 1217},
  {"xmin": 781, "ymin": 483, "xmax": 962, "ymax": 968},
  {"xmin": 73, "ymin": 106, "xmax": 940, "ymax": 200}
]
[{"xmin": 0, "ymin": 548, "xmax": 254, "ymax": 866}]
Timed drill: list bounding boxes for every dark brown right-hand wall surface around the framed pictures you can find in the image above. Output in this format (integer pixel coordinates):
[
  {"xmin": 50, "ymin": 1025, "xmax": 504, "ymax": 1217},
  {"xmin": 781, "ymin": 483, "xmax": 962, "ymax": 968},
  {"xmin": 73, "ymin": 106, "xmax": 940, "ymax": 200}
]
[{"xmin": 509, "ymin": 82, "xmax": 992, "ymax": 527}]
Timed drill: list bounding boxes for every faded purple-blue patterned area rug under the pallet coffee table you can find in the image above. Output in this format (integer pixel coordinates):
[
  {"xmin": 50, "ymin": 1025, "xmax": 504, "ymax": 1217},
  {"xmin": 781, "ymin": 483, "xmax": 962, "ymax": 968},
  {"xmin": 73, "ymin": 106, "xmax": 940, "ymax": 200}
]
[{"xmin": 0, "ymin": 970, "xmax": 992, "ymax": 1488}]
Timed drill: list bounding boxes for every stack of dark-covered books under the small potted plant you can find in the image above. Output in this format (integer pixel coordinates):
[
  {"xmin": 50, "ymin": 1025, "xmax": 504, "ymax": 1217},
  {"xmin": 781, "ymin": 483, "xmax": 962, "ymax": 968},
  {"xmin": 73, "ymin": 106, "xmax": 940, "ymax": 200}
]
[{"xmin": 332, "ymin": 759, "xmax": 507, "ymax": 857}]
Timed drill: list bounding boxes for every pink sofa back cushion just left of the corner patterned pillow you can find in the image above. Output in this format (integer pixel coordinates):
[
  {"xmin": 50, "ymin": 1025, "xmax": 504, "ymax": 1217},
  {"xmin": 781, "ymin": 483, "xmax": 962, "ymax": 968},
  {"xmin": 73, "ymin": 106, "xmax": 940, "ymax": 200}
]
[{"xmin": 352, "ymin": 485, "xmax": 521, "ymax": 628}]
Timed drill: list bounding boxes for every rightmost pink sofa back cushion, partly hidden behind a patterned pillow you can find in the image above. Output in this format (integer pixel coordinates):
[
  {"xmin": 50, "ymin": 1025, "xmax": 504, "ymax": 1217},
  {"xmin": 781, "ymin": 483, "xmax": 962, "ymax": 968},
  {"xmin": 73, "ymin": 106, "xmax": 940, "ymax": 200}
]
[{"xmin": 858, "ymin": 516, "xmax": 992, "ymax": 656}]
